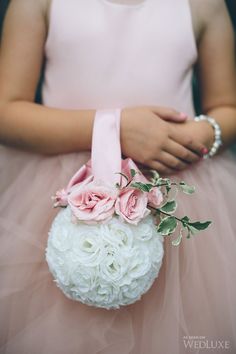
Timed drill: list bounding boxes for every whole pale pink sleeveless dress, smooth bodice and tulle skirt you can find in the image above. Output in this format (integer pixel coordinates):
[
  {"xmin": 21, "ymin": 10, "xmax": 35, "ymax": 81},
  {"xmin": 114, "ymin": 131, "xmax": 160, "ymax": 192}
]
[{"xmin": 0, "ymin": 0, "xmax": 236, "ymax": 354}]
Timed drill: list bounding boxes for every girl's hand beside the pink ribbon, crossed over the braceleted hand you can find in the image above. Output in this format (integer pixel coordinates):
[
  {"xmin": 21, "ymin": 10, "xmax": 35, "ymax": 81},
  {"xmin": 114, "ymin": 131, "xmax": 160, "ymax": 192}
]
[{"xmin": 121, "ymin": 107, "xmax": 205, "ymax": 174}]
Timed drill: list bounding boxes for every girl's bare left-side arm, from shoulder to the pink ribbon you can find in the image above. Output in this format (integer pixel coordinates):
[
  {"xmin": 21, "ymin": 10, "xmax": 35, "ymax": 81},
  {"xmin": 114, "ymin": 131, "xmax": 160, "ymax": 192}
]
[{"xmin": 0, "ymin": 0, "xmax": 95, "ymax": 153}]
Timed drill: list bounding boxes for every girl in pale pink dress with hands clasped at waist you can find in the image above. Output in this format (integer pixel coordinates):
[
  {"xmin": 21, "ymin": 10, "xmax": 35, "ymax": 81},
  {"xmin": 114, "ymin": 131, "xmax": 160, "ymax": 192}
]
[{"xmin": 0, "ymin": 0, "xmax": 236, "ymax": 354}]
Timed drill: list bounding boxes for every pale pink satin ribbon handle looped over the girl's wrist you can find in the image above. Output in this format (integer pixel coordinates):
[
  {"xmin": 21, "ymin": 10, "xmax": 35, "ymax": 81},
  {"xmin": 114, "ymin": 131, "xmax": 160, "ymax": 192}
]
[{"xmin": 91, "ymin": 109, "xmax": 121, "ymax": 185}]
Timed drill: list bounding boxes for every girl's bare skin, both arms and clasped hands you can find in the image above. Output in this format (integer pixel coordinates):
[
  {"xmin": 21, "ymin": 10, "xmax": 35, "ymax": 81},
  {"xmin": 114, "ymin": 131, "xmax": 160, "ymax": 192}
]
[{"xmin": 0, "ymin": 0, "xmax": 236, "ymax": 174}]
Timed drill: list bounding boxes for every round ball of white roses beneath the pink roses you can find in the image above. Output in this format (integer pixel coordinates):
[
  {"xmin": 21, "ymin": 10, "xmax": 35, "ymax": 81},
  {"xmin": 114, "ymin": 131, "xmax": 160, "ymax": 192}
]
[{"xmin": 46, "ymin": 207, "xmax": 164, "ymax": 309}]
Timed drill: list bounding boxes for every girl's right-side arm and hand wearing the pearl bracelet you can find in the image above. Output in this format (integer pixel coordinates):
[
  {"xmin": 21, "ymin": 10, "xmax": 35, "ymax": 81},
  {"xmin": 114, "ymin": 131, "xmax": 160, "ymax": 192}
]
[{"xmin": 170, "ymin": 0, "xmax": 236, "ymax": 151}]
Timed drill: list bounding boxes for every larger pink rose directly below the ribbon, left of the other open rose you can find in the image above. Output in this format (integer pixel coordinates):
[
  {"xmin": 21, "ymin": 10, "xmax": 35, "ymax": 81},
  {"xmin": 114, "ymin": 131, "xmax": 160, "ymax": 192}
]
[{"xmin": 68, "ymin": 182, "xmax": 117, "ymax": 224}]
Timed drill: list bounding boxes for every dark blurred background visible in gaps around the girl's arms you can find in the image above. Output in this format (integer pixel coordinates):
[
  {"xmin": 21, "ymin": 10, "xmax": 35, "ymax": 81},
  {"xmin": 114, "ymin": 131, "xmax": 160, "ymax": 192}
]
[{"xmin": 0, "ymin": 0, "xmax": 236, "ymax": 110}]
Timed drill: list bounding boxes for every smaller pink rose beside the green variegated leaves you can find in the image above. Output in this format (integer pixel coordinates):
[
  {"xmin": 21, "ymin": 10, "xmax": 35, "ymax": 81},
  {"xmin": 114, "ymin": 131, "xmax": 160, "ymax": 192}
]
[{"xmin": 115, "ymin": 188, "xmax": 150, "ymax": 225}]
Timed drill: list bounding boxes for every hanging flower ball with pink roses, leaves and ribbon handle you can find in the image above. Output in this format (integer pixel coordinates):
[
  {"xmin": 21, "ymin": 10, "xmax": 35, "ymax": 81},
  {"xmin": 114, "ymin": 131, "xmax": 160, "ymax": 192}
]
[{"xmin": 46, "ymin": 110, "xmax": 211, "ymax": 309}]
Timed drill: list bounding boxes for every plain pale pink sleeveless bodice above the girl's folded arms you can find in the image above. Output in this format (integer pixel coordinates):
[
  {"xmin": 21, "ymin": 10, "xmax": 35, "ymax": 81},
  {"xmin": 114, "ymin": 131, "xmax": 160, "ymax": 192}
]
[{"xmin": 43, "ymin": 0, "xmax": 197, "ymax": 114}]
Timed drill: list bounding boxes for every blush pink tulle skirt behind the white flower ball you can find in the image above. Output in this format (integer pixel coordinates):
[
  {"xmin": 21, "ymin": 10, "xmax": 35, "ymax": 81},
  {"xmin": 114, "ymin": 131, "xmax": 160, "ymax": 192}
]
[{"xmin": 0, "ymin": 147, "xmax": 236, "ymax": 354}]
